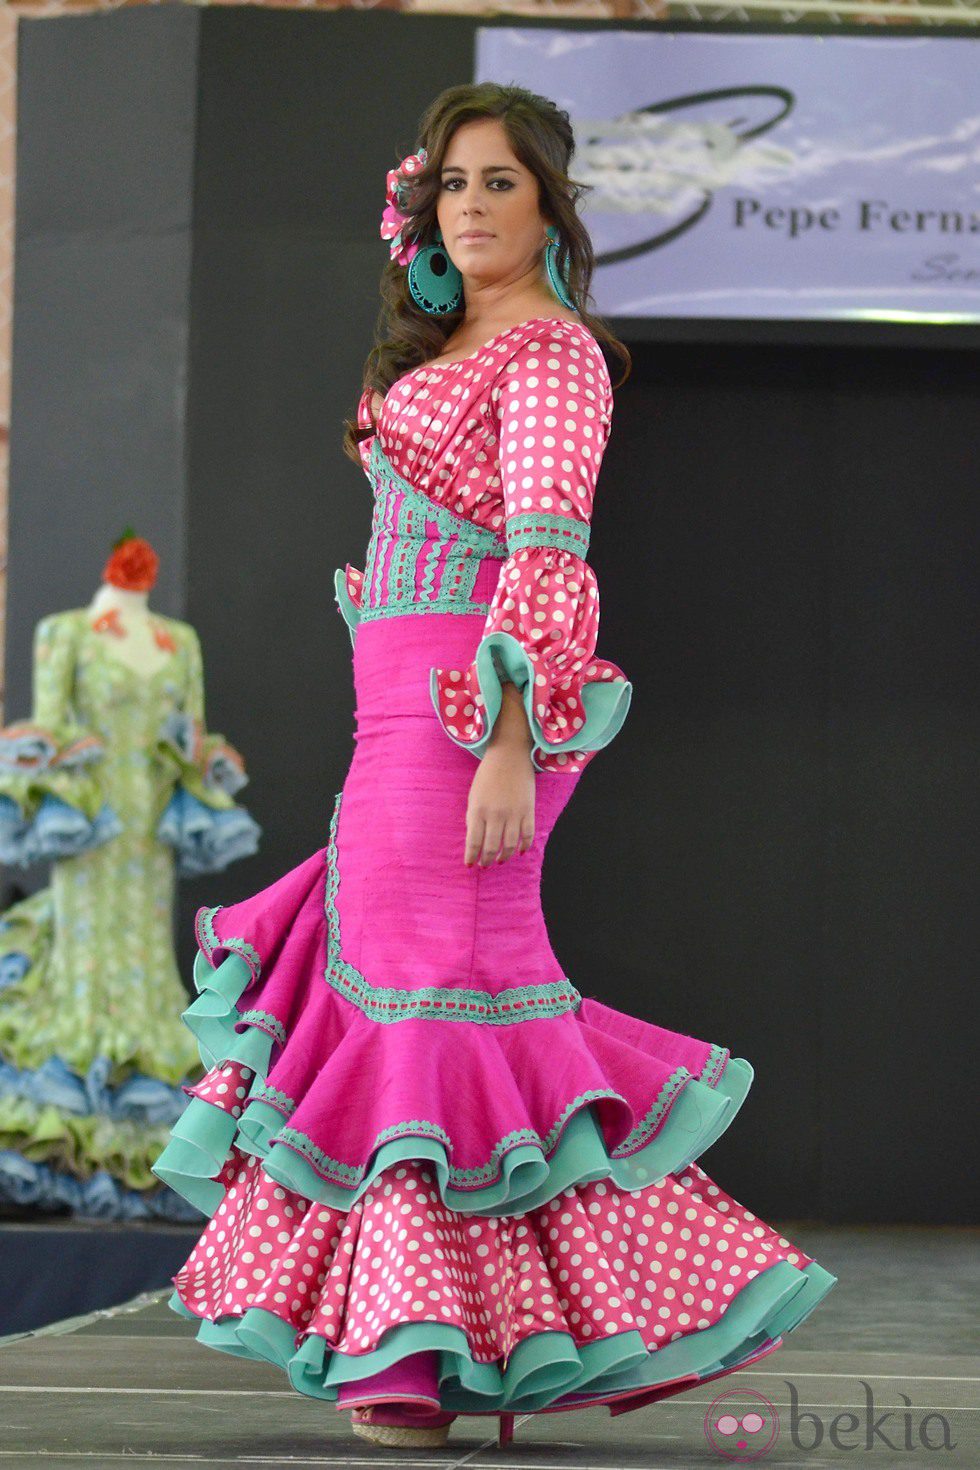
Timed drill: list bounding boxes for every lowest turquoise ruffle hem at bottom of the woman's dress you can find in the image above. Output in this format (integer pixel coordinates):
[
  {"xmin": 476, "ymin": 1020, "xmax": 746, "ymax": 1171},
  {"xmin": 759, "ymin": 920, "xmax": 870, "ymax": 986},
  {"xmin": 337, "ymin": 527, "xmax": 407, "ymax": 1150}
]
[{"xmin": 169, "ymin": 1261, "xmax": 837, "ymax": 1414}]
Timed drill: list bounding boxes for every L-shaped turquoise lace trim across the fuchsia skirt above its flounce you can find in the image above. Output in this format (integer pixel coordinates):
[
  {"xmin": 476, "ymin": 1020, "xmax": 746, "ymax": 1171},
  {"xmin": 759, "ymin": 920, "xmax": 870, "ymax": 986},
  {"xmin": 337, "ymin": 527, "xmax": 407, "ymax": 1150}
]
[{"xmin": 323, "ymin": 791, "xmax": 582, "ymax": 1026}]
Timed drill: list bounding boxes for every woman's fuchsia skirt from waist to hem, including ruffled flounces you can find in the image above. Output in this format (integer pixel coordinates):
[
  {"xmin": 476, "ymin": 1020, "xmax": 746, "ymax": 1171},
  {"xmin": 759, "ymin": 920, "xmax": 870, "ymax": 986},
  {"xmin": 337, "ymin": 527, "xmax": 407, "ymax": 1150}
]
[{"xmin": 154, "ymin": 560, "xmax": 836, "ymax": 1413}]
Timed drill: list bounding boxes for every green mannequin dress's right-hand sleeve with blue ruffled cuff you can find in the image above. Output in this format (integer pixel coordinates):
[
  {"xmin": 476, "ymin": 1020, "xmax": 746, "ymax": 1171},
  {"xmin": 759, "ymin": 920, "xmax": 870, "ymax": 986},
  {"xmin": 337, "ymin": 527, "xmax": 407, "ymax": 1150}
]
[{"xmin": 156, "ymin": 623, "xmax": 262, "ymax": 878}]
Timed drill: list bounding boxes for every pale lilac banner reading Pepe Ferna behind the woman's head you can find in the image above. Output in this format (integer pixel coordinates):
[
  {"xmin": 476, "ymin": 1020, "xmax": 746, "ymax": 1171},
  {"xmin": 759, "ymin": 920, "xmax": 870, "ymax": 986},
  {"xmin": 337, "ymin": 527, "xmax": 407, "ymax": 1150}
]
[{"xmin": 476, "ymin": 25, "xmax": 980, "ymax": 323}]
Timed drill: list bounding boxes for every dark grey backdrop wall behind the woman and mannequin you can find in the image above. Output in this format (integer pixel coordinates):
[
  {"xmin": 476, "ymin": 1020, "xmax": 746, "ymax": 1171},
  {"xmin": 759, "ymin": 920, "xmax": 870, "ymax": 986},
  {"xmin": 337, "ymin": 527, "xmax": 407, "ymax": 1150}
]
[{"xmin": 6, "ymin": 6, "xmax": 980, "ymax": 1222}]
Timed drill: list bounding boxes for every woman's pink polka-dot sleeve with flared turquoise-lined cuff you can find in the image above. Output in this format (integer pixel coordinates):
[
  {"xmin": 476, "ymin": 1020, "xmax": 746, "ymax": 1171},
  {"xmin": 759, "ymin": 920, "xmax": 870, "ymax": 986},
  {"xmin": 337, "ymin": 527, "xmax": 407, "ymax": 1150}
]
[{"xmin": 429, "ymin": 332, "xmax": 633, "ymax": 773}]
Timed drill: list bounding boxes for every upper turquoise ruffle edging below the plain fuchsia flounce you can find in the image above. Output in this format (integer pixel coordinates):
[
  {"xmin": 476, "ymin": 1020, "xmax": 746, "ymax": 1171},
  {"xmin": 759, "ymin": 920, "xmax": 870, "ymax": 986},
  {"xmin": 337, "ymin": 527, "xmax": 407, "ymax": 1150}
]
[{"xmin": 153, "ymin": 951, "xmax": 754, "ymax": 1216}]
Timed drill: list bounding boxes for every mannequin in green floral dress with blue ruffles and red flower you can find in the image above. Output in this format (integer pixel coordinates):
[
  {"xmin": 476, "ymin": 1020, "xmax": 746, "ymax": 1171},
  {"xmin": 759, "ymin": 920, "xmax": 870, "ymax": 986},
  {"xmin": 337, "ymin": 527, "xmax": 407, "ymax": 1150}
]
[{"xmin": 0, "ymin": 538, "xmax": 260, "ymax": 1219}]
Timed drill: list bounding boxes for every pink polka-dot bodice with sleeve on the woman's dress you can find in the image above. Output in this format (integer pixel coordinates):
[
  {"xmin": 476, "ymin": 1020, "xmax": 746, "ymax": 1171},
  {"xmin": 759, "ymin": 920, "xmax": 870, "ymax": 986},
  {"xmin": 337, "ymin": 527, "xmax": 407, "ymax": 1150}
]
[{"xmin": 347, "ymin": 318, "xmax": 632, "ymax": 773}]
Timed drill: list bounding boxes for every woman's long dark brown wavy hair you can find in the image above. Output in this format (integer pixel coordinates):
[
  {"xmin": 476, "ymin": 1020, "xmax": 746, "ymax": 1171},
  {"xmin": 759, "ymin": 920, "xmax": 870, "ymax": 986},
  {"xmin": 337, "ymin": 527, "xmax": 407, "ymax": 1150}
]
[{"xmin": 344, "ymin": 82, "xmax": 632, "ymax": 466}]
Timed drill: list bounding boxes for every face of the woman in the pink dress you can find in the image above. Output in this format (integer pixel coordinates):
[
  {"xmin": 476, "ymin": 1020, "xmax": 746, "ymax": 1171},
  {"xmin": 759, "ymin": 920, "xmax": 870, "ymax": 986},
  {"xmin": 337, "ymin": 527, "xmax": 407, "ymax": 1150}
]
[{"xmin": 436, "ymin": 118, "xmax": 548, "ymax": 285}]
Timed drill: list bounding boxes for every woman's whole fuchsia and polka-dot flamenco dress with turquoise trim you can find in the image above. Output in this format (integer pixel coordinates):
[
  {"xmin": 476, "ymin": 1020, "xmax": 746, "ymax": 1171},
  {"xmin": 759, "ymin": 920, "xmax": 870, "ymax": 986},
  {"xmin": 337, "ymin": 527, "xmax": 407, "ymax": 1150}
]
[{"xmin": 153, "ymin": 318, "xmax": 836, "ymax": 1442}]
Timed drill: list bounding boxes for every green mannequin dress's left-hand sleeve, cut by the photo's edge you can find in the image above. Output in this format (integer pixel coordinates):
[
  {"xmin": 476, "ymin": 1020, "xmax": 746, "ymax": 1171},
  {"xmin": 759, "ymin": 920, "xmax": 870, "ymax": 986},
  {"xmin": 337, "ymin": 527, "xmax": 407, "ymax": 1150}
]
[{"xmin": 0, "ymin": 612, "xmax": 122, "ymax": 867}]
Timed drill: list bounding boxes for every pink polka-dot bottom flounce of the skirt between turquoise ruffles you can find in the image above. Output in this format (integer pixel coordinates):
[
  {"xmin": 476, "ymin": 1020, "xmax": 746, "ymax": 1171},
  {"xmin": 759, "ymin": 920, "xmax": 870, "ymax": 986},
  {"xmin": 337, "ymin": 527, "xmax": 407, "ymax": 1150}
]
[{"xmin": 173, "ymin": 1150, "xmax": 813, "ymax": 1363}]
